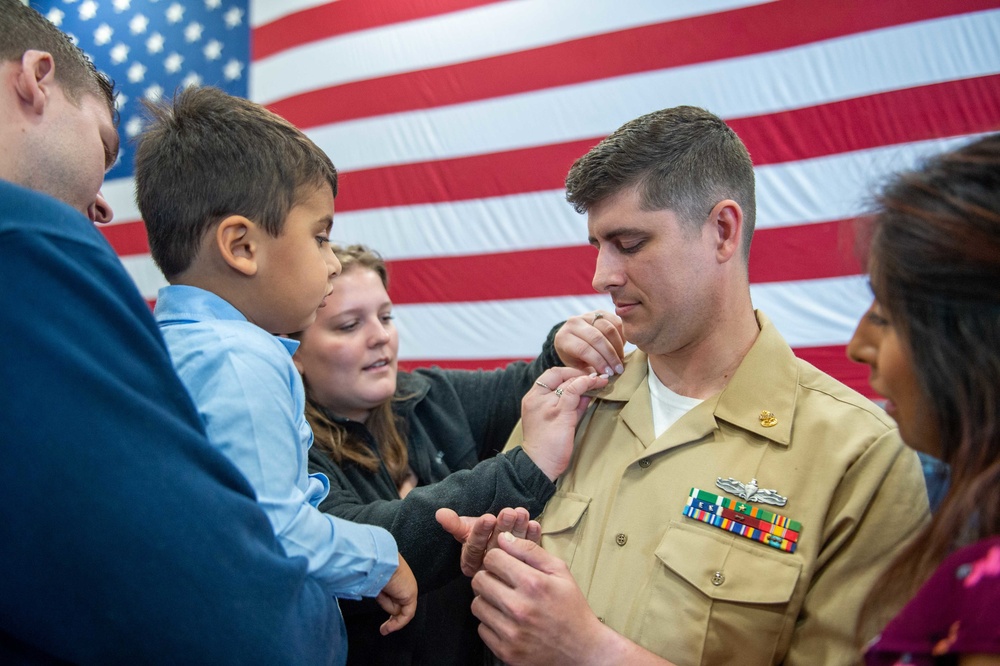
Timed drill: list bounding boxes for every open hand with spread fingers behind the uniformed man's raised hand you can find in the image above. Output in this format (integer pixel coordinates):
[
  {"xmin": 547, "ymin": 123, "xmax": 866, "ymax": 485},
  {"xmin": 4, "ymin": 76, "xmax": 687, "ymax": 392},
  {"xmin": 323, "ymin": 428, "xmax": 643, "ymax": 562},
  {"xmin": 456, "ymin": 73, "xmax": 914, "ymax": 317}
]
[{"xmin": 434, "ymin": 507, "xmax": 542, "ymax": 577}]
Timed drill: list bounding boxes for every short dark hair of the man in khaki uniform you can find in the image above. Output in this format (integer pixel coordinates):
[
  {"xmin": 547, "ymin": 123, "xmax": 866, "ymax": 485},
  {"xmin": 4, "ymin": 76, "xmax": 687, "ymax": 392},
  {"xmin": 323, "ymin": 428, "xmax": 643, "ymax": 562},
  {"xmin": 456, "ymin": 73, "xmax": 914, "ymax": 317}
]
[{"xmin": 566, "ymin": 106, "xmax": 757, "ymax": 262}]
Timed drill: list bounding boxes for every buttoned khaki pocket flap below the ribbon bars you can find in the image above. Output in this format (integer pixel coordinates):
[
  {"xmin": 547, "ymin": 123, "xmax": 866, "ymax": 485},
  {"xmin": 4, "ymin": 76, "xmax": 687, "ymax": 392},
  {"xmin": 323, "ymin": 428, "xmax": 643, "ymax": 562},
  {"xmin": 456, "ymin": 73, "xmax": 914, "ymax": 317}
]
[{"xmin": 656, "ymin": 521, "xmax": 802, "ymax": 604}]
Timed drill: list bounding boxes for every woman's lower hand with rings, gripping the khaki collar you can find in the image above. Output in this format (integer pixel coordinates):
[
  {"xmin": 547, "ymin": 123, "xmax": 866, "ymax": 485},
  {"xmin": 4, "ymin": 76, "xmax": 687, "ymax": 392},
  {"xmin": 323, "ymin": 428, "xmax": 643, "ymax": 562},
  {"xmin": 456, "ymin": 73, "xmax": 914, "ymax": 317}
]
[{"xmin": 521, "ymin": 368, "xmax": 608, "ymax": 481}]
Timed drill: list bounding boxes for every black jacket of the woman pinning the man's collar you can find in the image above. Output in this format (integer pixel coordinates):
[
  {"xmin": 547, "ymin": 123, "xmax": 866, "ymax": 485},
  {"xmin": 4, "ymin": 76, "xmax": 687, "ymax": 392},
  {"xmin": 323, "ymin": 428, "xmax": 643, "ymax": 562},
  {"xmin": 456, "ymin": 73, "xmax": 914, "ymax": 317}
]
[{"xmin": 309, "ymin": 326, "xmax": 560, "ymax": 666}]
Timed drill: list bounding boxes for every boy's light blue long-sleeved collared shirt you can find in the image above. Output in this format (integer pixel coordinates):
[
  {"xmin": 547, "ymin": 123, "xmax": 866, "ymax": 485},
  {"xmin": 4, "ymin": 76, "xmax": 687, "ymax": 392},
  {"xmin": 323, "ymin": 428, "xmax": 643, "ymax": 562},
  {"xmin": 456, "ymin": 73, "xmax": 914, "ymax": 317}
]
[{"xmin": 154, "ymin": 285, "xmax": 399, "ymax": 599}]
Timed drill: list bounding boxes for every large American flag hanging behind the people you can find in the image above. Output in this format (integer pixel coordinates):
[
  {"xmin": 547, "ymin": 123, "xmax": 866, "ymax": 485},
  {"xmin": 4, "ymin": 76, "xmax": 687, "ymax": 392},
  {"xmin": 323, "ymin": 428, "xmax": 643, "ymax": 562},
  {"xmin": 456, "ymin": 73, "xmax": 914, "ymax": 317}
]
[{"xmin": 43, "ymin": 0, "xmax": 1000, "ymax": 393}]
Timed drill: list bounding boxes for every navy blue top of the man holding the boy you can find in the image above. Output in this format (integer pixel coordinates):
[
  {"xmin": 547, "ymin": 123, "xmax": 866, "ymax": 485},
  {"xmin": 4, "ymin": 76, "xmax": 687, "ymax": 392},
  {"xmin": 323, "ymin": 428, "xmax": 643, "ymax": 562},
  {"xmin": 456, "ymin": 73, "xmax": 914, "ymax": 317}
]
[{"xmin": 0, "ymin": 182, "xmax": 346, "ymax": 664}]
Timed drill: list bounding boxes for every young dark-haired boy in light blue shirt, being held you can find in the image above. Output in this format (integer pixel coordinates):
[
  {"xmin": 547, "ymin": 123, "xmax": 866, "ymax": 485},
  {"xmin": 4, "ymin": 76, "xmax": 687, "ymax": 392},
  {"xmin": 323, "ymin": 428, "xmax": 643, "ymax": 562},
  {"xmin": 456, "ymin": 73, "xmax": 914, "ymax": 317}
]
[{"xmin": 136, "ymin": 87, "xmax": 416, "ymax": 657}]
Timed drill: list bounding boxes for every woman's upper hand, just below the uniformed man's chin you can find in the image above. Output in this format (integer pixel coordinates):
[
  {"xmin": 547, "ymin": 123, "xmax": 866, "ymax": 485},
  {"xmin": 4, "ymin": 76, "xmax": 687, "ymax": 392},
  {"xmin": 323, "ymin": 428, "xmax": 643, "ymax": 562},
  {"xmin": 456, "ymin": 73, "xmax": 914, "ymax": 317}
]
[{"xmin": 554, "ymin": 310, "xmax": 625, "ymax": 376}]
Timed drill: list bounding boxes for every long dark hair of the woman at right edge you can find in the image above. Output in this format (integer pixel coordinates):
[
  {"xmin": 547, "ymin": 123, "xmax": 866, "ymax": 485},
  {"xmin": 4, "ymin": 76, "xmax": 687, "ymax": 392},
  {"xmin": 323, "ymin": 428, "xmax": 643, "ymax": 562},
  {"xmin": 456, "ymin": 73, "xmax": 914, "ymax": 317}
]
[{"xmin": 866, "ymin": 134, "xmax": 1000, "ymax": 636}]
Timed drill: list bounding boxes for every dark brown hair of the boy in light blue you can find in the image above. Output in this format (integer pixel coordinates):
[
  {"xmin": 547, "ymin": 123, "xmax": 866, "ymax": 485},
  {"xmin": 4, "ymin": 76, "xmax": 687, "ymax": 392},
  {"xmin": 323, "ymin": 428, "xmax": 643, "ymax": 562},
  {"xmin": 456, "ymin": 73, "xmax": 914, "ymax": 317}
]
[{"xmin": 135, "ymin": 86, "xmax": 337, "ymax": 280}]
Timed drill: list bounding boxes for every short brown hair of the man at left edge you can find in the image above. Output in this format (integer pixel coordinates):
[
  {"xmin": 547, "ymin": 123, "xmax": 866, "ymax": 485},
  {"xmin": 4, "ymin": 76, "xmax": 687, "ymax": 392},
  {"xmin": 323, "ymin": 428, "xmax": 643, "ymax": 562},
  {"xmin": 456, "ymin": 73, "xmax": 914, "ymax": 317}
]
[{"xmin": 0, "ymin": 0, "xmax": 117, "ymax": 117}]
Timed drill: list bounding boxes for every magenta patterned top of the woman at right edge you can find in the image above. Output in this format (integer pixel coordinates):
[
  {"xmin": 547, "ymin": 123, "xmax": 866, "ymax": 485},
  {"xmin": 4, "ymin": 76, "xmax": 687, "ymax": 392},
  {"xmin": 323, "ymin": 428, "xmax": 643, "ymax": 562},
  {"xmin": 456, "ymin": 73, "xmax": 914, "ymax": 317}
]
[{"xmin": 865, "ymin": 536, "xmax": 1000, "ymax": 666}]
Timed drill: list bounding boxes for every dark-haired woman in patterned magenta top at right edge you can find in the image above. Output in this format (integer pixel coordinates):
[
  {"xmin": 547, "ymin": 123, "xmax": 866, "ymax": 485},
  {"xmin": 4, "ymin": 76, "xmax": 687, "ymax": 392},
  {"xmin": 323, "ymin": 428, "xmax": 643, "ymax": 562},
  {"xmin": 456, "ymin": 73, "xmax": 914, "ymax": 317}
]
[{"xmin": 848, "ymin": 134, "xmax": 1000, "ymax": 666}]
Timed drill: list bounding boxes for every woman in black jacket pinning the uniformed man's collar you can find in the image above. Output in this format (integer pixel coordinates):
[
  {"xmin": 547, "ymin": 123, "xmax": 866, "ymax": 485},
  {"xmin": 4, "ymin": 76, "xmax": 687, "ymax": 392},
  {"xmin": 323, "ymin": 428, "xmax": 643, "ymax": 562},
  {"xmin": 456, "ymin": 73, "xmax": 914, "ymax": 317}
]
[{"xmin": 295, "ymin": 245, "xmax": 624, "ymax": 665}]
